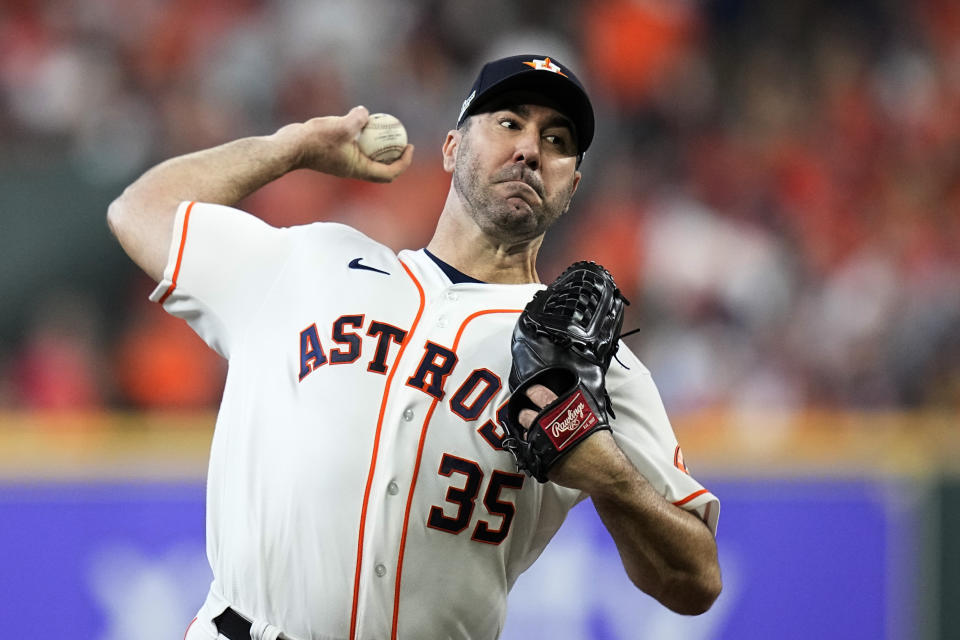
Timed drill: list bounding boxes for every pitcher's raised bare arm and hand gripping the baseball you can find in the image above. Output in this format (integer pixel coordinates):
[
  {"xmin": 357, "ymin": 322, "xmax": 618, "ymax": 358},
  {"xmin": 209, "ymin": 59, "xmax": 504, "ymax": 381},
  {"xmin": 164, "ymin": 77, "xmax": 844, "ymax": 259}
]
[{"xmin": 107, "ymin": 107, "xmax": 413, "ymax": 282}]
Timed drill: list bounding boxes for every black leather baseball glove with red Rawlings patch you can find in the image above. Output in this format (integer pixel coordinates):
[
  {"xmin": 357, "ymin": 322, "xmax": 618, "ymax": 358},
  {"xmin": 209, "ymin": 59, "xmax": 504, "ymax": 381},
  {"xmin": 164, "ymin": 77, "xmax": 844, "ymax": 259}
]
[{"xmin": 503, "ymin": 262, "xmax": 629, "ymax": 482}]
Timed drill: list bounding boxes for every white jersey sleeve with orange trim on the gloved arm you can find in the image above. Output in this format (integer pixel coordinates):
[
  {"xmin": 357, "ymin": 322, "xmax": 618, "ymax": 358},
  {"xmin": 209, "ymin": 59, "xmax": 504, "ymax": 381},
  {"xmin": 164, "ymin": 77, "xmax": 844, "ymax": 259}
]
[{"xmin": 607, "ymin": 344, "xmax": 720, "ymax": 535}]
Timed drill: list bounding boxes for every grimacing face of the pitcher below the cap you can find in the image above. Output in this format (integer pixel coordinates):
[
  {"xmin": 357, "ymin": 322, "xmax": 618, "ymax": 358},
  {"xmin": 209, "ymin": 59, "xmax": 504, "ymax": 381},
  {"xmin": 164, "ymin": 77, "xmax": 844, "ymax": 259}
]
[{"xmin": 448, "ymin": 104, "xmax": 580, "ymax": 242}]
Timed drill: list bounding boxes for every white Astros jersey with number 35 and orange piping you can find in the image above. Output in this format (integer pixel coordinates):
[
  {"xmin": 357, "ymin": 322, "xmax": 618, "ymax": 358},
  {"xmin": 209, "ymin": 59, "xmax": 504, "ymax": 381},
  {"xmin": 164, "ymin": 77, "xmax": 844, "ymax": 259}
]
[{"xmin": 151, "ymin": 203, "xmax": 719, "ymax": 640}]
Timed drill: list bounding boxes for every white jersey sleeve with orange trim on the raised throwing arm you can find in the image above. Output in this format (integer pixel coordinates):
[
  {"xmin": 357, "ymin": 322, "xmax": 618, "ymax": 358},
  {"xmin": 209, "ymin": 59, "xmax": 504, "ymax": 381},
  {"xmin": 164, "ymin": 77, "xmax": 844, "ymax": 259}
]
[{"xmin": 150, "ymin": 202, "xmax": 291, "ymax": 358}]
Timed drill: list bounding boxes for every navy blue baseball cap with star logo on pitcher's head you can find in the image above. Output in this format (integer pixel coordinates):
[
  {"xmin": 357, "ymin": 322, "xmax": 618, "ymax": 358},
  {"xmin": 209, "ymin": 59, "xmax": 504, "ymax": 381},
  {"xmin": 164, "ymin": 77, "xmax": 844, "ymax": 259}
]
[{"xmin": 457, "ymin": 54, "xmax": 594, "ymax": 164}]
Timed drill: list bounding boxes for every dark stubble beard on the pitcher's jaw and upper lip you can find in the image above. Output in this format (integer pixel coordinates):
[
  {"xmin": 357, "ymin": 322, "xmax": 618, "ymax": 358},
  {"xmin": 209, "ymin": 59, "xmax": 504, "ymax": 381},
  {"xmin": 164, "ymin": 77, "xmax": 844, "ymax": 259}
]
[{"xmin": 453, "ymin": 136, "xmax": 574, "ymax": 242}]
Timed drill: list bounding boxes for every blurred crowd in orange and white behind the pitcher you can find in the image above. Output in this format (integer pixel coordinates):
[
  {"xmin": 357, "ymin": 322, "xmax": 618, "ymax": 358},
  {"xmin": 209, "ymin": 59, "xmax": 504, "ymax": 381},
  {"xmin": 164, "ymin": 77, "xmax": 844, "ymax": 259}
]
[{"xmin": 0, "ymin": 0, "xmax": 960, "ymax": 411}]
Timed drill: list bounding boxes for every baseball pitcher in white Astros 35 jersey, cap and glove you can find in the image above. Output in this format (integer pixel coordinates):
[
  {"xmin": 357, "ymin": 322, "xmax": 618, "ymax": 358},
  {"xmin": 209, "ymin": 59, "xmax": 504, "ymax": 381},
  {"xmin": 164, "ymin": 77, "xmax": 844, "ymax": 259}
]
[{"xmin": 107, "ymin": 55, "xmax": 721, "ymax": 640}]
